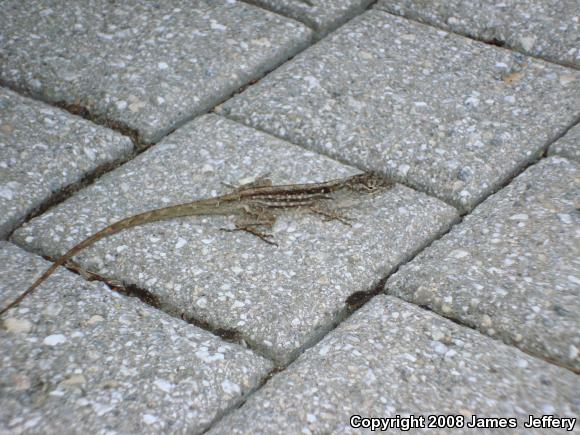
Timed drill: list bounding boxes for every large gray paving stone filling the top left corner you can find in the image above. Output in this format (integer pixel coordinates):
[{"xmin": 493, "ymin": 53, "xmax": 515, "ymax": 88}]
[{"xmin": 0, "ymin": 0, "xmax": 312, "ymax": 142}]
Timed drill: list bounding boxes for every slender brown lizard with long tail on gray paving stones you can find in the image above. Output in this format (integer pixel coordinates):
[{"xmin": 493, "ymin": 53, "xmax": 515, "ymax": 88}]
[{"xmin": 0, "ymin": 172, "xmax": 392, "ymax": 316}]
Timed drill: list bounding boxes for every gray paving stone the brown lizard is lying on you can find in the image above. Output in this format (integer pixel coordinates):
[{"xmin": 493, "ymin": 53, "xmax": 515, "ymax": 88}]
[{"xmin": 13, "ymin": 115, "xmax": 457, "ymax": 363}]
